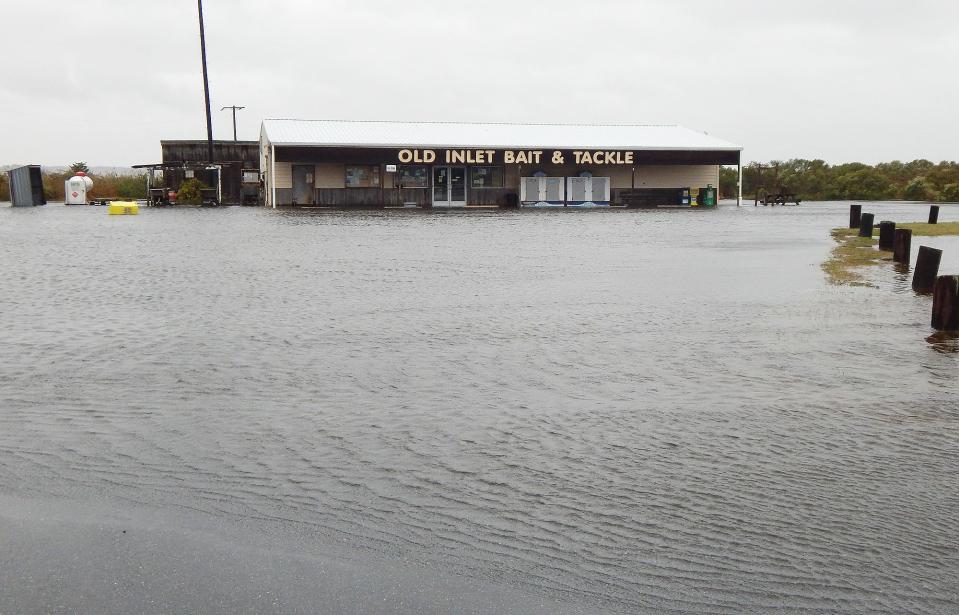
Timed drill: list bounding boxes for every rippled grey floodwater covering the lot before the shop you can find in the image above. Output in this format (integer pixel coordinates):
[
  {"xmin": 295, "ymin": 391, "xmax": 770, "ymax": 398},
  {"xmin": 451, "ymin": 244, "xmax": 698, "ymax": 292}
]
[{"xmin": 0, "ymin": 203, "xmax": 959, "ymax": 614}]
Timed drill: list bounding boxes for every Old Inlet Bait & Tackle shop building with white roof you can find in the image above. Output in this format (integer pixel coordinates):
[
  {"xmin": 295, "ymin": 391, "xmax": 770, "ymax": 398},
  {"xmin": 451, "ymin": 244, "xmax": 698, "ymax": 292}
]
[{"xmin": 260, "ymin": 119, "xmax": 741, "ymax": 207}]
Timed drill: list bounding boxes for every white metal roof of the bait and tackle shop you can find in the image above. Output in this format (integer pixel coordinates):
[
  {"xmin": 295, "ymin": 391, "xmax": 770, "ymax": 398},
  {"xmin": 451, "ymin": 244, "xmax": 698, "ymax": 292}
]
[{"xmin": 263, "ymin": 119, "xmax": 742, "ymax": 151}]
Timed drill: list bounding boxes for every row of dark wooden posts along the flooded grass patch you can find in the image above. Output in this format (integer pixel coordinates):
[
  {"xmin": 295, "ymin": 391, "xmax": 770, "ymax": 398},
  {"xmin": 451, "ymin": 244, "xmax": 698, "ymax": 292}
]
[{"xmin": 849, "ymin": 205, "xmax": 959, "ymax": 331}]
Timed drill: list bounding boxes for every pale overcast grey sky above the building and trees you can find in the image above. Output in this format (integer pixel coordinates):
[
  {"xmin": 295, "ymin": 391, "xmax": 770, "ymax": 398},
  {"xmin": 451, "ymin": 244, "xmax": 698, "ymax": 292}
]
[{"xmin": 0, "ymin": 0, "xmax": 959, "ymax": 165}]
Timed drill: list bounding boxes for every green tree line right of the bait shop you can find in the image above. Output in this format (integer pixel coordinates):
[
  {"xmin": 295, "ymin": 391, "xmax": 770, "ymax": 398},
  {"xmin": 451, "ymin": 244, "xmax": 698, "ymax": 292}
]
[{"xmin": 719, "ymin": 159, "xmax": 959, "ymax": 202}]
